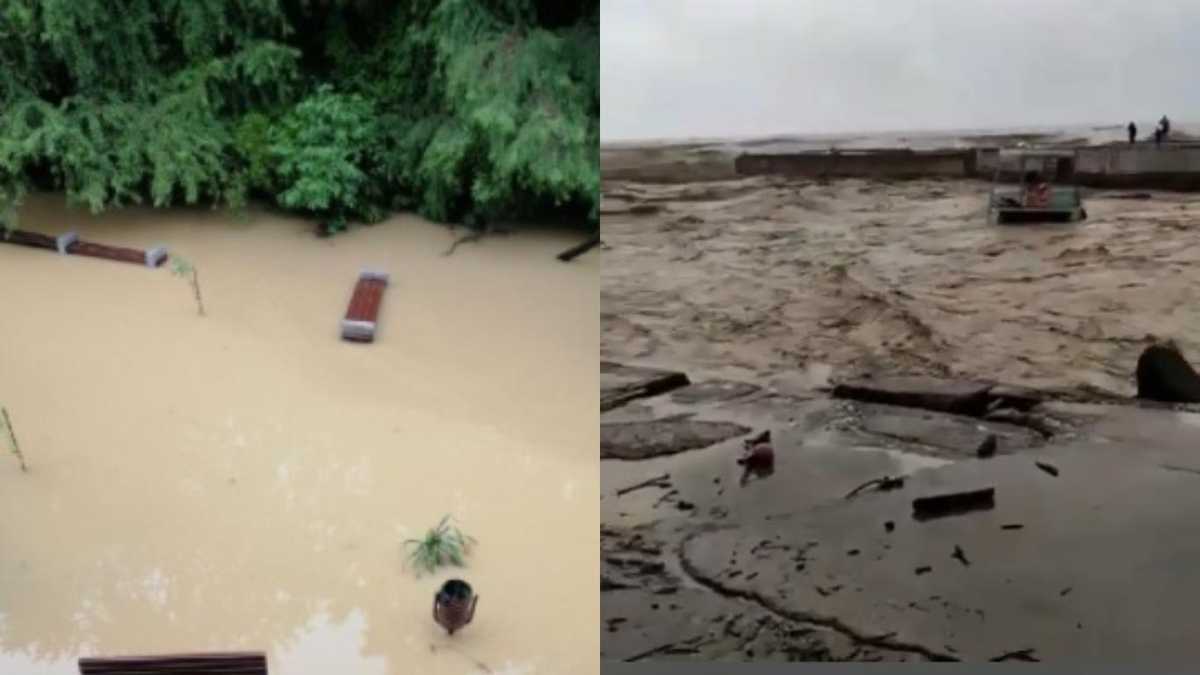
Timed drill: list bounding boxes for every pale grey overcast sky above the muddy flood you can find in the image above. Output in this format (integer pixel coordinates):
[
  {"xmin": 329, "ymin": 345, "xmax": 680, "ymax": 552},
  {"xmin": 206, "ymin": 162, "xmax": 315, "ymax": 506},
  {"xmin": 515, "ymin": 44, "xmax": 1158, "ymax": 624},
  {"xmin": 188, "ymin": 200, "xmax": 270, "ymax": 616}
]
[{"xmin": 600, "ymin": 0, "xmax": 1200, "ymax": 141}]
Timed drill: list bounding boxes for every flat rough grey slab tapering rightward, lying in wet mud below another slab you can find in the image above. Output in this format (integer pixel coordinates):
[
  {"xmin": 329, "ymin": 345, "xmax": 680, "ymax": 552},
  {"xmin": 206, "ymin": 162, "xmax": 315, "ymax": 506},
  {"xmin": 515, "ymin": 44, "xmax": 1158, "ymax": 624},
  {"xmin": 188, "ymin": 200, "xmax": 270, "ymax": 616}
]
[{"xmin": 600, "ymin": 418, "xmax": 750, "ymax": 460}]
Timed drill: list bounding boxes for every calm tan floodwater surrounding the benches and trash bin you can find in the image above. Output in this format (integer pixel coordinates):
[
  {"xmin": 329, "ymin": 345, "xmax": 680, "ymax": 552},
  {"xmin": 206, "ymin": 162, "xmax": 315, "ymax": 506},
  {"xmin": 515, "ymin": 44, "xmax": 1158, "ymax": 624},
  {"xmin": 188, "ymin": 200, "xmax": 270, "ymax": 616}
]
[{"xmin": 0, "ymin": 196, "xmax": 600, "ymax": 675}]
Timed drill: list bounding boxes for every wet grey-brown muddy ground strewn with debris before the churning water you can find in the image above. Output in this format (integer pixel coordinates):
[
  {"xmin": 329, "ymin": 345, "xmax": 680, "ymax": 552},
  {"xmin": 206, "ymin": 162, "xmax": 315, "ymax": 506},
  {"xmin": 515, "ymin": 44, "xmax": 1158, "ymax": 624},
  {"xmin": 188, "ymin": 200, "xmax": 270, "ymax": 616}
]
[{"xmin": 601, "ymin": 360, "xmax": 1200, "ymax": 661}]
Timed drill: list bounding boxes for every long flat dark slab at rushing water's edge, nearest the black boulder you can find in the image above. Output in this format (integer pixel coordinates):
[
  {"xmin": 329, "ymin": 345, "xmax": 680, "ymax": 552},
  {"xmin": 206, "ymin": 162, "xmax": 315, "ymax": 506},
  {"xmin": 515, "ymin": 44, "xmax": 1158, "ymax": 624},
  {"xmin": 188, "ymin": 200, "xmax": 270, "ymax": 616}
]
[{"xmin": 833, "ymin": 377, "xmax": 992, "ymax": 417}]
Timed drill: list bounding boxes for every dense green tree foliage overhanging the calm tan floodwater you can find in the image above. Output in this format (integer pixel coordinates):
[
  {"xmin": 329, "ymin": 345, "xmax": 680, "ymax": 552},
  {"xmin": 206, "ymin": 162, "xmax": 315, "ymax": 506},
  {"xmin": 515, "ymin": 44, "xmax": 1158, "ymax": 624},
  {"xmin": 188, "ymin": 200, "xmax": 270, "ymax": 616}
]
[{"xmin": 0, "ymin": 0, "xmax": 600, "ymax": 225}]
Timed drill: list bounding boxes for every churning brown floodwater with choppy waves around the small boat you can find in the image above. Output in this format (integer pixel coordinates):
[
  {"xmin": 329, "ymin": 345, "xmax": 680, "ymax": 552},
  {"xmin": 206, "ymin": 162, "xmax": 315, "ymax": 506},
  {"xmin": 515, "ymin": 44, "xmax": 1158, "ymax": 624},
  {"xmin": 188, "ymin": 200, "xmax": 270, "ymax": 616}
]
[{"xmin": 601, "ymin": 167, "xmax": 1200, "ymax": 395}]
